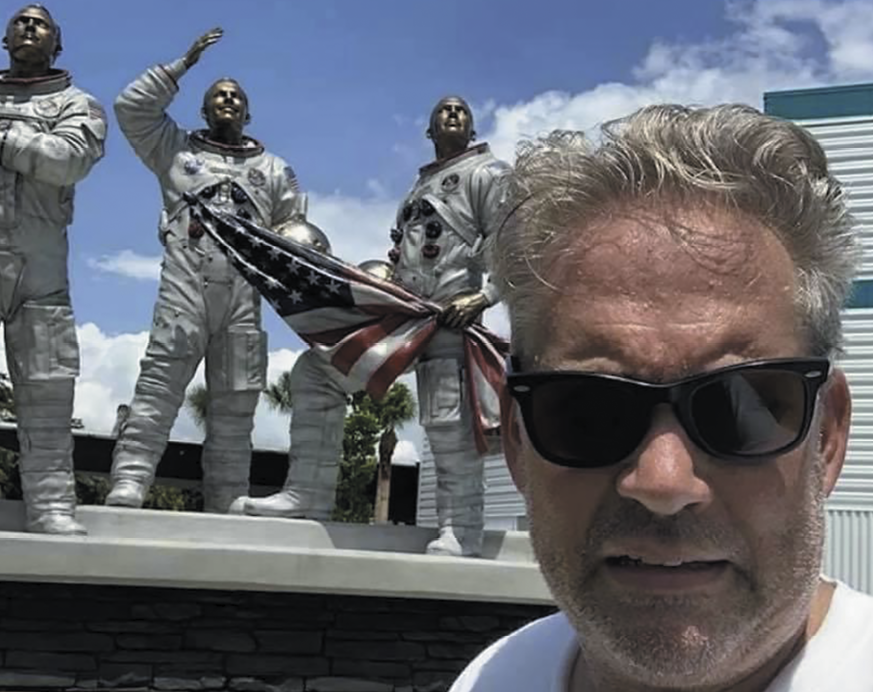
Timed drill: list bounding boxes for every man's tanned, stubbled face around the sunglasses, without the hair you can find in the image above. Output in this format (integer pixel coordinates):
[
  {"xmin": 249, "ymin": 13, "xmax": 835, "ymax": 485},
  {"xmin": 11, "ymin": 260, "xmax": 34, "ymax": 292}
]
[{"xmin": 504, "ymin": 204, "xmax": 848, "ymax": 689}]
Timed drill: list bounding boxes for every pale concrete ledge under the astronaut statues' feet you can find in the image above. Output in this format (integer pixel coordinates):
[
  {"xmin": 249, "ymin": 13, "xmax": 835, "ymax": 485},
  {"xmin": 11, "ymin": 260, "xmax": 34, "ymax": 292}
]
[{"xmin": 0, "ymin": 500, "xmax": 551, "ymax": 604}]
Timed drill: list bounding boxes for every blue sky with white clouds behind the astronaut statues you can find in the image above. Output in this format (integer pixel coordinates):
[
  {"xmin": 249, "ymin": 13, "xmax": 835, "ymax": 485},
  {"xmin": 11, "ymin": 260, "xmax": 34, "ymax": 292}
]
[{"xmin": 6, "ymin": 0, "xmax": 873, "ymax": 454}]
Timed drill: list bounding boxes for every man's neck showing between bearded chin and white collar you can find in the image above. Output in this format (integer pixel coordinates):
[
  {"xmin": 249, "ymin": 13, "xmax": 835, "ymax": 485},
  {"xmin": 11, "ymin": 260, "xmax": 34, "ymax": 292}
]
[{"xmin": 567, "ymin": 581, "xmax": 835, "ymax": 692}]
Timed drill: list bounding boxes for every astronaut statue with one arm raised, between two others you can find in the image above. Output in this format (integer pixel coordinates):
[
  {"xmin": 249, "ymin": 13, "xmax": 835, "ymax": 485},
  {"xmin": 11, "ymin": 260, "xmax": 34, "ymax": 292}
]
[{"xmin": 106, "ymin": 29, "xmax": 298, "ymax": 512}]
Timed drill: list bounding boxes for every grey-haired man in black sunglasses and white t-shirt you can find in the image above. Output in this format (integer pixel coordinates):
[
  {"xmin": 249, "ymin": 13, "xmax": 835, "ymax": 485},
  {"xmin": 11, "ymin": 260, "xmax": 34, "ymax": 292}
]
[{"xmin": 453, "ymin": 106, "xmax": 873, "ymax": 692}]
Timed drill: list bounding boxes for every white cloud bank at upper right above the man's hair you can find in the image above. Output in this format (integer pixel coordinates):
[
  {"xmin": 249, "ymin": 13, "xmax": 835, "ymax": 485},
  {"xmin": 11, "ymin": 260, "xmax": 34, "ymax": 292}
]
[{"xmin": 486, "ymin": 0, "xmax": 873, "ymax": 160}]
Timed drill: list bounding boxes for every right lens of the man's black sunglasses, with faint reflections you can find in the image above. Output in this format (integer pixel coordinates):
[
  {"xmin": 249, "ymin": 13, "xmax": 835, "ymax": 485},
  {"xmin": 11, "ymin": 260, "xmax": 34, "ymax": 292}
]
[{"xmin": 691, "ymin": 369, "xmax": 806, "ymax": 457}]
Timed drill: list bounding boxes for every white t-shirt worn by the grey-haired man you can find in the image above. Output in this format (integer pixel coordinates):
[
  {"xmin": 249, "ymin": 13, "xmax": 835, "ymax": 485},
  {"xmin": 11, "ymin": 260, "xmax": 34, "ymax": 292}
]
[{"xmin": 449, "ymin": 583, "xmax": 873, "ymax": 692}]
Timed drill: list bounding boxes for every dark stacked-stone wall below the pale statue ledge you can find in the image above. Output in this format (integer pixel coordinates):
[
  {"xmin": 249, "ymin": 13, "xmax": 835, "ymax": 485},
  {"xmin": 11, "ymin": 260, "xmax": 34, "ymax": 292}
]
[{"xmin": 0, "ymin": 582, "xmax": 554, "ymax": 692}]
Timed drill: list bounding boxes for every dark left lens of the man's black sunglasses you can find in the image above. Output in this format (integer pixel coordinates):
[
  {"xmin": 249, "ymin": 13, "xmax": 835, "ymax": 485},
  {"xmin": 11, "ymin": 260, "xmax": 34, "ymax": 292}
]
[{"xmin": 530, "ymin": 377, "xmax": 651, "ymax": 468}]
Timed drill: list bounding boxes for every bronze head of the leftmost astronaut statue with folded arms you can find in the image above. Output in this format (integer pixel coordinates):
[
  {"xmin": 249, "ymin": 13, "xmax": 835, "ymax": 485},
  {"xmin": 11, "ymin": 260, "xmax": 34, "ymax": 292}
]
[{"xmin": 3, "ymin": 4, "xmax": 61, "ymax": 78}]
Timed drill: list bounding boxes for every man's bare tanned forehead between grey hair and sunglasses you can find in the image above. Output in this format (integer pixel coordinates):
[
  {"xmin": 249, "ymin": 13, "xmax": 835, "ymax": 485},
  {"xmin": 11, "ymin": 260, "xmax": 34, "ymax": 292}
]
[{"xmin": 520, "ymin": 201, "xmax": 795, "ymax": 366}]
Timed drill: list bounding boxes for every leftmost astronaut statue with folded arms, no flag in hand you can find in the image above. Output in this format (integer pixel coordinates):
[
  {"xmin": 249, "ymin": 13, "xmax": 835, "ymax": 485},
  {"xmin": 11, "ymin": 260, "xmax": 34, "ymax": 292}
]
[{"xmin": 0, "ymin": 4, "xmax": 106, "ymax": 534}]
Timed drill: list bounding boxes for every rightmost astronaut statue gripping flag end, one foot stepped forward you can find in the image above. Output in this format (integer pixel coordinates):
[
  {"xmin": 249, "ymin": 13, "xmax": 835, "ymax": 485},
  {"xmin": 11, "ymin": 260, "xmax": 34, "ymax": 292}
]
[{"xmin": 234, "ymin": 97, "xmax": 508, "ymax": 555}]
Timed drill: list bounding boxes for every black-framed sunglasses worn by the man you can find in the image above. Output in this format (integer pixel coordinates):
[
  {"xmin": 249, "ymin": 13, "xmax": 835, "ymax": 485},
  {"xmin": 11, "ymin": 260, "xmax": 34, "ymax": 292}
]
[{"xmin": 506, "ymin": 357, "xmax": 830, "ymax": 468}]
